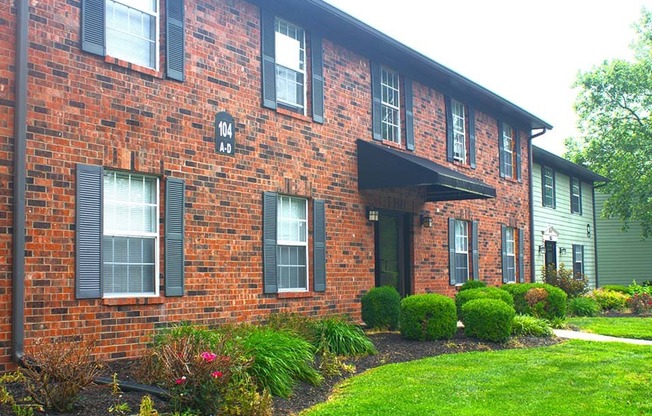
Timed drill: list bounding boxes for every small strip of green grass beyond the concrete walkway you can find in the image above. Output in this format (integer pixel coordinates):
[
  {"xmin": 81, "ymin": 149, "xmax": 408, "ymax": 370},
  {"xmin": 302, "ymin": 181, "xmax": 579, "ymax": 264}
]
[{"xmin": 567, "ymin": 317, "xmax": 652, "ymax": 340}]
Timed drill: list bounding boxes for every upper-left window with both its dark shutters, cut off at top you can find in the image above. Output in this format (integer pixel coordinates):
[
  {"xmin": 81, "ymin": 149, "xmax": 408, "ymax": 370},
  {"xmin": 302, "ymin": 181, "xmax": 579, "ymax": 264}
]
[{"xmin": 81, "ymin": 0, "xmax": 185, "ymax": 81}]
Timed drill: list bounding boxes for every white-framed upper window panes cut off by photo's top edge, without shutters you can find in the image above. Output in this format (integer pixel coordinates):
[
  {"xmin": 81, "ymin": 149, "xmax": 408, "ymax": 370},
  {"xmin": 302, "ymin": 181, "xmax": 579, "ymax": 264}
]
[{"xmin": 106, "ymin": 0, "xmax": 159, "ymax": 70}]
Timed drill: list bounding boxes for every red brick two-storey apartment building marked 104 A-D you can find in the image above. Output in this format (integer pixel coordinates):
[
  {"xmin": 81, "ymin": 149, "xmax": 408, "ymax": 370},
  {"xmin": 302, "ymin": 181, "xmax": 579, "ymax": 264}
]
[{"xmin": 0, "ymin": 0, "xmax": 551, "ymax": 370}]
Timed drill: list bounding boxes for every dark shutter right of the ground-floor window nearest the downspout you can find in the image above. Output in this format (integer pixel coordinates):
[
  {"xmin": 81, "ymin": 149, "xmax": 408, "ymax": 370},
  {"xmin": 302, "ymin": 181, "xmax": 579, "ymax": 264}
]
[{"xmin": 165, "ymin": 178, "xmax": 186, "ymax": 296}]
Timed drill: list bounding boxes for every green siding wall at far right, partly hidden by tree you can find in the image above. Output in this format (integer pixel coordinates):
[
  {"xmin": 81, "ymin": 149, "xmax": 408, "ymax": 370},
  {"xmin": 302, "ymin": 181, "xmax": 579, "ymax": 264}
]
[{"xmin": 595, "ymin": 192, "xmax": 652, "ymax": 286}]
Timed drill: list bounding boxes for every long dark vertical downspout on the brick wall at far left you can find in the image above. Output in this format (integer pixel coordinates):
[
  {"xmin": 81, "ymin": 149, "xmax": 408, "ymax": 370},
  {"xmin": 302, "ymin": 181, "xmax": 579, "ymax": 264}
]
[{"xmin": 11, "ymin": 0, "xmax": 29, "ymax": 362}]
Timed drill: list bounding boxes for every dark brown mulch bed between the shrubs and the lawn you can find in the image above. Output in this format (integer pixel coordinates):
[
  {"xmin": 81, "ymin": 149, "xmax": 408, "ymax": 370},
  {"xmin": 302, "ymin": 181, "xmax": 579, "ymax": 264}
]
[{"xmin": 0, "ymin": 330, "xmax": 560, "ymax": 416}]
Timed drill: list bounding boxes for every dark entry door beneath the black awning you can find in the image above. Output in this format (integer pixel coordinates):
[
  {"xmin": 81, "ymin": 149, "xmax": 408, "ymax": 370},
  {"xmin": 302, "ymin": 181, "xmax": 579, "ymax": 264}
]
[{"xmin": 376, "ymin": 212, "xmax": 410, "ymax": 297}]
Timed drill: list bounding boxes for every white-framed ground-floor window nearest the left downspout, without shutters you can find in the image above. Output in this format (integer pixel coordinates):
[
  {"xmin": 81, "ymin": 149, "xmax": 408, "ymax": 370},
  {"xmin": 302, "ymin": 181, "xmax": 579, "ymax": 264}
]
[{"xmin": 102, "ymin": 171, "xmax": 159, "ymax": 297}]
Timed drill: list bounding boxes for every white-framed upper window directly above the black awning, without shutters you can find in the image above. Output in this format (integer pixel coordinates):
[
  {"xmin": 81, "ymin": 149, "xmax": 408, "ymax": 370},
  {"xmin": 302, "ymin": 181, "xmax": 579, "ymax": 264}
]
[{"xmin": 380, "ymin": 67, "xmax": 401, "ymax": 144}]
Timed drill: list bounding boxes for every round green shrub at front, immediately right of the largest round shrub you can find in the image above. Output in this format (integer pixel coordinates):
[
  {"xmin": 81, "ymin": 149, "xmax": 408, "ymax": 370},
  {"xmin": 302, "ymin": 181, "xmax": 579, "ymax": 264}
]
[{"xmin": 462, "ymin": 299, "xmax": 516, "ymax": 342}]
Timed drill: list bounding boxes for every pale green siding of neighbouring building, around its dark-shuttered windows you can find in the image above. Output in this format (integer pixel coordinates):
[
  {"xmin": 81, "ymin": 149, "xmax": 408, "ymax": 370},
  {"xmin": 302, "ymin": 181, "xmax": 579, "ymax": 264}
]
[{"xmin": 532, "ymin": 163, "xmax": 602, "ymax": 288}]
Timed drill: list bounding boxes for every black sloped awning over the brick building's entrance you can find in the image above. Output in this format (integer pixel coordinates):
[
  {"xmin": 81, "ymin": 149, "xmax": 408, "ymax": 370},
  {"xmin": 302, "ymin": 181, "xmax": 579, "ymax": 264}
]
[{"xmin": 357, "ymin": 139, "xmax": 496, "ymax": 202}]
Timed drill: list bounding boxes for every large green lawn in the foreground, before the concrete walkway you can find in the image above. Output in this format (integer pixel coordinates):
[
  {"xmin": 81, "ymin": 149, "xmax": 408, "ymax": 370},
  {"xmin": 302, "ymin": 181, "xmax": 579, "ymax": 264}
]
[{"xmin": 301, "ymin": 341, "xmax": 652, "ymax": 416}]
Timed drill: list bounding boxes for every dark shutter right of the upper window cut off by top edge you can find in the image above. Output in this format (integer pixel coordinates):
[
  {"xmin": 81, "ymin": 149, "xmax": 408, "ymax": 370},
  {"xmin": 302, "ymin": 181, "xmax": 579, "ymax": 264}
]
[{"xmin": 165, "ymin": 0, "xmax": 186, "ymax": 81}]
